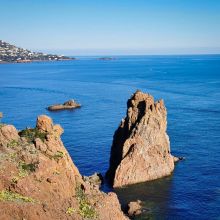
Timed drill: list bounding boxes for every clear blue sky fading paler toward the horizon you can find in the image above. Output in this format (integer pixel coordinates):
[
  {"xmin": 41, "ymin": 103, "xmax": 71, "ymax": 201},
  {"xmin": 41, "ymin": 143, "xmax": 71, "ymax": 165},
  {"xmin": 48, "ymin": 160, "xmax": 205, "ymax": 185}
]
[{"xmin": 0, "ymin": 0, "xmax": 220, "ymax": 55}]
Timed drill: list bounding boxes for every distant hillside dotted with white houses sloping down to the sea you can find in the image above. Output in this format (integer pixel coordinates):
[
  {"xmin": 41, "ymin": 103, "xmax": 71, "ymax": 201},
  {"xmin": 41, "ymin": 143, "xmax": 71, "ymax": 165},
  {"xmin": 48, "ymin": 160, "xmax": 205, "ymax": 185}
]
[{"xmin": 0, "ymin": 40, "xmax": 74, "ymax": 63}]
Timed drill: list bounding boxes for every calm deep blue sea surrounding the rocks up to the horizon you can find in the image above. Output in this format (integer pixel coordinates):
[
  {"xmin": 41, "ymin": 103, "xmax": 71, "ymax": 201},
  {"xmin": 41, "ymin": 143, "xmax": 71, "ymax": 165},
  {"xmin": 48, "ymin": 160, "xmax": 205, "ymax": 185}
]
[{"xmin": 0, "ymin": 55, "xmax": 220, "ymax": 219}]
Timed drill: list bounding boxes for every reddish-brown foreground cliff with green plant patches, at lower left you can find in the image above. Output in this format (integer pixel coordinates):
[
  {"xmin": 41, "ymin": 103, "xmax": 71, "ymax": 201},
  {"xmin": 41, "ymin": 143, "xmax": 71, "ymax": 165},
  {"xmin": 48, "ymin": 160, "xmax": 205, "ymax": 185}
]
[{"xmin": 0, "ymin": 116, "xmax": 127, "ymax": 220}]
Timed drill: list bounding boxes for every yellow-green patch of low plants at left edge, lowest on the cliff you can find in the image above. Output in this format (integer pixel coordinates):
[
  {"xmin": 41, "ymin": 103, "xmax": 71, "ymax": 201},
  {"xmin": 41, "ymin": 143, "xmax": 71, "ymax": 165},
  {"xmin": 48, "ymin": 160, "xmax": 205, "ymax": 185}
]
[{"xmin": 0, "ymin": 190, "xmax": 36, "ymax": 203}]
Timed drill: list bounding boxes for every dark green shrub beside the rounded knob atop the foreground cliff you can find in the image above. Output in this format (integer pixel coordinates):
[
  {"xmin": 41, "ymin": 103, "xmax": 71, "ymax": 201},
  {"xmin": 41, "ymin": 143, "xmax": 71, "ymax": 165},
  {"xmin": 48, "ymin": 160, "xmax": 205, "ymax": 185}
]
[{"xmin": 19, "ymin": 128, "xmax": 47, "ymax": 142}]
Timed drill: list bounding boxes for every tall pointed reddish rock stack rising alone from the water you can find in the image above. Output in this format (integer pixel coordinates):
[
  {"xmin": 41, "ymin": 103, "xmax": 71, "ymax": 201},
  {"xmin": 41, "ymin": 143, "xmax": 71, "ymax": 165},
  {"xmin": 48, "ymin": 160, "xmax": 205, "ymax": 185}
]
[{"xmin": 106, "ymin": 91, "xmax": 174, "ymax": 187}]
